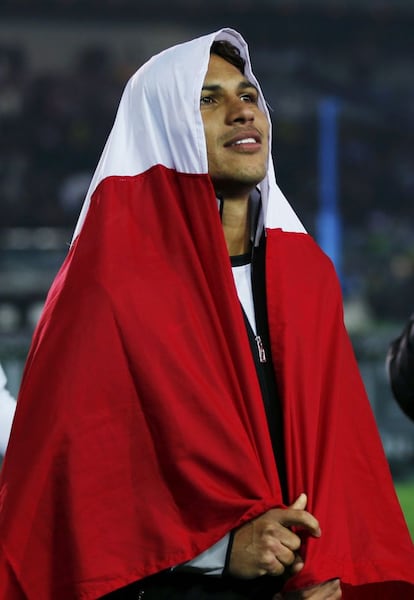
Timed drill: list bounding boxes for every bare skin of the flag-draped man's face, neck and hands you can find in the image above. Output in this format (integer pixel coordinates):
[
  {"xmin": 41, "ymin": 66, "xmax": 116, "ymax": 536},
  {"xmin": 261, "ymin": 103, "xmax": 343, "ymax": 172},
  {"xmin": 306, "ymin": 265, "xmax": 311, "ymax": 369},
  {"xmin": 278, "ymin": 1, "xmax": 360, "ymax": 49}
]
[{"xmin": 200, "ymin": 55, "xmax": 341, "ymax": 600}]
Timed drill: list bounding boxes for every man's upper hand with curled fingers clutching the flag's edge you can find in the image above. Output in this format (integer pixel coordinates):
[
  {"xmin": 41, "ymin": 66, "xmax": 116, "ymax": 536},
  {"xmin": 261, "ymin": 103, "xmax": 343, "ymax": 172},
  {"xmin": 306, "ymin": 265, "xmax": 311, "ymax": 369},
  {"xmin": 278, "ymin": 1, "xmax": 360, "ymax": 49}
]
[{"xmin": 229, "ymin": 494, "xmax": 321, "ymax": 579}]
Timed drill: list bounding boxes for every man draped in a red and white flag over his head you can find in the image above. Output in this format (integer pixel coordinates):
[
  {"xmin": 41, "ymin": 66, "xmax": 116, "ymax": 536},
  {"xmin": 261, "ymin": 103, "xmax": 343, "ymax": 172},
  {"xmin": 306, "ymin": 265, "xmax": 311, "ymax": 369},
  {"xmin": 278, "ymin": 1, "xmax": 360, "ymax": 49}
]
[{"xmin": 0, "ymin": 29, "xmax": 414, "ymax": 600}]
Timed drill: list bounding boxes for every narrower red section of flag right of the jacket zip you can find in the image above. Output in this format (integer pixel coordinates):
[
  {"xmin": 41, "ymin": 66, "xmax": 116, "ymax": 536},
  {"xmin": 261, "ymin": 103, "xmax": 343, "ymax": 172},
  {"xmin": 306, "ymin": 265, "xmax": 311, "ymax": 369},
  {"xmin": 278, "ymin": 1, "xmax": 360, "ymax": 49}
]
[{"xmin": 267, "ymin": 230, "xmax": 414, "ymax": 600}]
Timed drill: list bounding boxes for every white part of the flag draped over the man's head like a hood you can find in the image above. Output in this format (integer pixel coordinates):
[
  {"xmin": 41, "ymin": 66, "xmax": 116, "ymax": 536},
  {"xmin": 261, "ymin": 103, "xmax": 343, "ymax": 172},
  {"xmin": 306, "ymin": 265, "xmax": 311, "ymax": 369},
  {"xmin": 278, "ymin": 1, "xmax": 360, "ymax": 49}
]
[{"xmin": 74, "ymin": 29, "xmax": 305, "ymax": 238}]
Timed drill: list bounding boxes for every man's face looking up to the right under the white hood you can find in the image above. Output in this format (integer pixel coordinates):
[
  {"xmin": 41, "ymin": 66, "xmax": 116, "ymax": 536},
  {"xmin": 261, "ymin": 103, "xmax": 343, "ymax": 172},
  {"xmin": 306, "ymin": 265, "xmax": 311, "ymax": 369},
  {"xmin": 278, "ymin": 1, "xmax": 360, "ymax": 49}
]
[{"xmin": 200, "ymin": 54, "xmax": 269, "ymax": 197}]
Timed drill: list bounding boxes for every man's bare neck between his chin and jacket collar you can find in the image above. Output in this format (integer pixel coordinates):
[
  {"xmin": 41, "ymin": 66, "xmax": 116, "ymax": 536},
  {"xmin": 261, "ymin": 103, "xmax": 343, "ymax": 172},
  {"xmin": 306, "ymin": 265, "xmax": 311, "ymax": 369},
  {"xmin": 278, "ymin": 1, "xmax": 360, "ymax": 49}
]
[{"xmin": 221, "ymin": 197, "xmax": 250, "ymax": 256}]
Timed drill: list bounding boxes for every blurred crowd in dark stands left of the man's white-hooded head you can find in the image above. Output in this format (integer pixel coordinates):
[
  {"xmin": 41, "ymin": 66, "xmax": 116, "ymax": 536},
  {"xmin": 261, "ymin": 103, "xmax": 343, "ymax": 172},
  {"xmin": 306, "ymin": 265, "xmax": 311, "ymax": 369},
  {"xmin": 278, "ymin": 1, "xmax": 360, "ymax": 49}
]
[{"xmin": 0, "ymin": 46, "xmax": 132, "ymax": 227}]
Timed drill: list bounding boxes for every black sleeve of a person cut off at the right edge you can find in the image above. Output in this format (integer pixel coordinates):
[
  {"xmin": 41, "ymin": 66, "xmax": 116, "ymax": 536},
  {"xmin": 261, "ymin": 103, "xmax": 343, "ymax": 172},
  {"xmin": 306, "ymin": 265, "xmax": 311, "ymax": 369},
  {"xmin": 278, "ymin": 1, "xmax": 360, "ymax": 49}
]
[{"xmin": 387, "ymin": 314, "xmax": 414, "ymax": 421}]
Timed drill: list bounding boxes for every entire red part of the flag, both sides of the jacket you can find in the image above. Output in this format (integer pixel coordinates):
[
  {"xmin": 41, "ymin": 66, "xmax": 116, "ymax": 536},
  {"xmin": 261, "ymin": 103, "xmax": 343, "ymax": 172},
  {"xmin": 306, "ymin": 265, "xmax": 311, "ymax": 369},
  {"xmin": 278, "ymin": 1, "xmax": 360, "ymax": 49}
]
[{"xmin": 0, "ymin": 166, "xmax": 414, "ymax": 600}]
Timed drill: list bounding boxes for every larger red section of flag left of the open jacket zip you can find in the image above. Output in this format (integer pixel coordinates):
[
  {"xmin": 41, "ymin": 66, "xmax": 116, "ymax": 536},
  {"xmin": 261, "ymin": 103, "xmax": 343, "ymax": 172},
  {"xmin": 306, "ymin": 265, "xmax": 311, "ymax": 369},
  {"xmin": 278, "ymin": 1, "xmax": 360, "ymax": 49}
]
[{"xmin": 0, "ymin": 167, "xmax": 281, "ymax": 600}]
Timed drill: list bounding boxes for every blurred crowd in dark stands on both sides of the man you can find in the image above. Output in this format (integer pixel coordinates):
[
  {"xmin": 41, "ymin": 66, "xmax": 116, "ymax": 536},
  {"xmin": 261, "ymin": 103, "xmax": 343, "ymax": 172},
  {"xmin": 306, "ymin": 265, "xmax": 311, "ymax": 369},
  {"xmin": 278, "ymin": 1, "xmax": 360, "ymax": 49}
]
[{"xmin": 0, "ymin": 5, "xmax": 414, "ymax": 328}]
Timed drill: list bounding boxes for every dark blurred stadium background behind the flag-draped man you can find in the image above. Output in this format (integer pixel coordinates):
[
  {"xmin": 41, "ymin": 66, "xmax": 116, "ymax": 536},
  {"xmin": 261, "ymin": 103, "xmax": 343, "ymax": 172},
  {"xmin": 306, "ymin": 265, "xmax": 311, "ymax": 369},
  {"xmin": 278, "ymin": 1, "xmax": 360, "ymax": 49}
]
[{"xmin": 0, "ymin": 0, "xmax": 414, "ymax": 519}]
